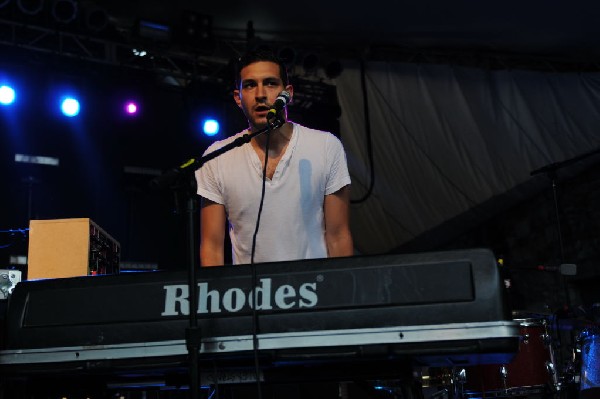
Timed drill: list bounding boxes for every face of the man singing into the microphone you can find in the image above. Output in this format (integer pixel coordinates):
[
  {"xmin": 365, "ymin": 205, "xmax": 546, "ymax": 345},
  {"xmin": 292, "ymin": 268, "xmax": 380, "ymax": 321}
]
[{"xmin": 233, "ymin": 61, "xmax": 293, "ymax": 130}]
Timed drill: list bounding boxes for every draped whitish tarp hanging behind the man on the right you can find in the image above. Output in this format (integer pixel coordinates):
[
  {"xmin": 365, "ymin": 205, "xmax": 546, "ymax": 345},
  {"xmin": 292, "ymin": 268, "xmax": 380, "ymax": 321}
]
[{"xmin": 336, "ymin": 62, "xmax": 600, "ymax": 254}]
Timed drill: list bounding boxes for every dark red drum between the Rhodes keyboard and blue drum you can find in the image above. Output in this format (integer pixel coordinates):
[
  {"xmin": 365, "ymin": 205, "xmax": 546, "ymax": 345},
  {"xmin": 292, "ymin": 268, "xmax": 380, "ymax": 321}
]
[{"xmin": 463, "ymin": 319, "xmax": 554, "ymax": 398}]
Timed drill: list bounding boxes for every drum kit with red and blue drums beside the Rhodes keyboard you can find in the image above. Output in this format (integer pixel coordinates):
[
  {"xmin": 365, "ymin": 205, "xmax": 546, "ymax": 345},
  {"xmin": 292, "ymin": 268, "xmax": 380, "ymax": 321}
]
[{"xmin": 421, "ymin": 312, "xmax": 600, "ymax": 399}]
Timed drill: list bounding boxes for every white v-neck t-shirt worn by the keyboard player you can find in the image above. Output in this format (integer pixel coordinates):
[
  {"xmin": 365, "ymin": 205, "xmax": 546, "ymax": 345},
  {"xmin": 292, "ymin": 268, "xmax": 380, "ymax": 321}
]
[{"xmin": 196, "ymin": 123, "xmax": 350, "ymax": 264}]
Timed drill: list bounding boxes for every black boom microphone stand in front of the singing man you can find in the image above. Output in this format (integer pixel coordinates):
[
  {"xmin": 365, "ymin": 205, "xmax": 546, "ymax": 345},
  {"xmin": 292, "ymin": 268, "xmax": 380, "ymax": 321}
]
[{"xmin": 150, "ymin": 115, "xmax": 285, "ymax": 399}]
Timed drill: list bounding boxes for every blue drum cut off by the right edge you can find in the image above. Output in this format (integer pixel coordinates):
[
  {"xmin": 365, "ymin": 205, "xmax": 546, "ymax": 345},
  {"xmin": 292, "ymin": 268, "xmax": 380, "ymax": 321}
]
[{"xmin": 579, "ymin": 329, "xmax": 600, "ymax": 399}]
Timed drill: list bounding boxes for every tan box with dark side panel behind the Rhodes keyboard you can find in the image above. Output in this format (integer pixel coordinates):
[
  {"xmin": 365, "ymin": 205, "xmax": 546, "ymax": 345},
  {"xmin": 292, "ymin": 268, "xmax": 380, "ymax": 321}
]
[{"xmin": 27, "ymin": 218, "xmax": 121, "ymax": 280}]
